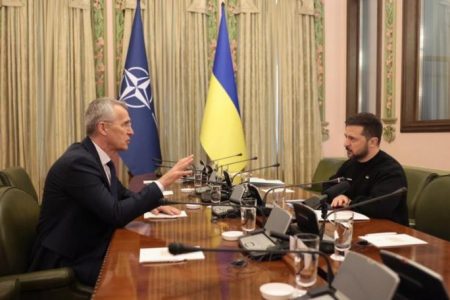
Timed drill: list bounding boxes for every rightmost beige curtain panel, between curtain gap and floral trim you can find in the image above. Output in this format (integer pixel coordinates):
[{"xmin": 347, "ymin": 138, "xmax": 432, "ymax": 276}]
[{"xmin": 274, "ymin": 0, "xmax": 322, "ymax": 183}]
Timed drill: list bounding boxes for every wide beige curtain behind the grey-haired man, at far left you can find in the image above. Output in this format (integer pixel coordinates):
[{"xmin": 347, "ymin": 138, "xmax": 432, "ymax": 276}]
[{"xmin": 0, "ymin": 0, "xmax": 95, "ymax": 202}]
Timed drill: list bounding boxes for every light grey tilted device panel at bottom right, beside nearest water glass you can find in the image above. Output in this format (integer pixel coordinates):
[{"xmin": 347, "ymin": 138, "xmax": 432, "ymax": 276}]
[{"xmin": 333, "ymin": 251, "xmax": 400, "ymax": 300}]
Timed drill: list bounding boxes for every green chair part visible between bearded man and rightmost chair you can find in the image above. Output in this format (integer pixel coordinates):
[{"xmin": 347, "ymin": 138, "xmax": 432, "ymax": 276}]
[{"xmin": 403, "ymin": 166, "xmax": 438, "ymax": 227}]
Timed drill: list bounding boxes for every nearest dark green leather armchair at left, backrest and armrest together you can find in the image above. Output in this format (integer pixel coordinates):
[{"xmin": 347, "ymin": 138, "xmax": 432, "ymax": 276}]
[{"xmin": 0, "ymin": 186, "xmax": 92, "ymax": 300}]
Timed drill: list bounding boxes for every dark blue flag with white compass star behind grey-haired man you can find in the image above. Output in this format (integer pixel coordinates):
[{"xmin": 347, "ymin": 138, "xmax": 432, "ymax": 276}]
[{"xmin": 119, "ymin": 0, "xmax": 161, "ymax": 175}]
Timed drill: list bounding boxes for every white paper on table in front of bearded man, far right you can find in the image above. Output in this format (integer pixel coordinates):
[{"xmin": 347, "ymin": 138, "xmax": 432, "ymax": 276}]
[{"xmin": 359, "ymin": 232, "xmax": 427, "ymax": 248}]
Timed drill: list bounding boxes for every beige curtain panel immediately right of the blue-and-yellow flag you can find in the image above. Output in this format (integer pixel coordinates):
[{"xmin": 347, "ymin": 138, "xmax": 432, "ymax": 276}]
[{"xmin": 236, "ymin": 0, "xmax": 281, "ymax": 178}]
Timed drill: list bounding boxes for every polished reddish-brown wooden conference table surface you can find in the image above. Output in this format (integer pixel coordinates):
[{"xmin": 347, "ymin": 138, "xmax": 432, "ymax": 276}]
[{"xmin": 93, "ymin": 184, "xmax": 450, "ymax": 299}]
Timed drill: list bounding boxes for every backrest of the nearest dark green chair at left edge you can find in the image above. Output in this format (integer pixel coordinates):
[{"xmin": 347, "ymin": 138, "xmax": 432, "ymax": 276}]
[{"xmin": 0, "ymin": 187, "xmax": 39, "ymax": 276}]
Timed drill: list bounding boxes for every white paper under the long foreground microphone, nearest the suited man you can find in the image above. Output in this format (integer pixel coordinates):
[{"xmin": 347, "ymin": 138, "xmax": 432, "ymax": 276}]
[{"xmin": 139, "ymin": 247, "xmax": 205, "ymax": 263}]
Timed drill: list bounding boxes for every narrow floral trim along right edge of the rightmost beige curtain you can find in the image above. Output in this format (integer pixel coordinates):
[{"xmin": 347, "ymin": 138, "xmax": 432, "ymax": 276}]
[{"xmin": 314, "ymin": 0, "xmax": 330, "ymax": 141}]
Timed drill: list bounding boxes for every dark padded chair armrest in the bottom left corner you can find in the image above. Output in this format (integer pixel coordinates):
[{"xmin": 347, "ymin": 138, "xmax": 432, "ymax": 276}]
[{"xmin": 0, "ymin": 268, "xmax": 76, "ymax": 291}]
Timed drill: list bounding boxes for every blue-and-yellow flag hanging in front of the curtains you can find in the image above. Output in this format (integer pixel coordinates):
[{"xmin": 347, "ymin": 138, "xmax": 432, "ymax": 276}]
[{"xmin": 200, "ymin": 5, "xmax": 248, "ymax": 172}]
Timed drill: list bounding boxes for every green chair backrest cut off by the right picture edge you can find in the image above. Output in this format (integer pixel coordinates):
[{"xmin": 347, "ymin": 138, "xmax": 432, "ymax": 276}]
[{"xmin": 416, "ymin": 175, "xmax": 450, "ymax": 241}]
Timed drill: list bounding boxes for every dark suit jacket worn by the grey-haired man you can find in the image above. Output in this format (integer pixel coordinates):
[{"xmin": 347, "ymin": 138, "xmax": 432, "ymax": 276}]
[{"xmin": 29, "ymin": 138, "xmax": 162, "ymax": 285}]
